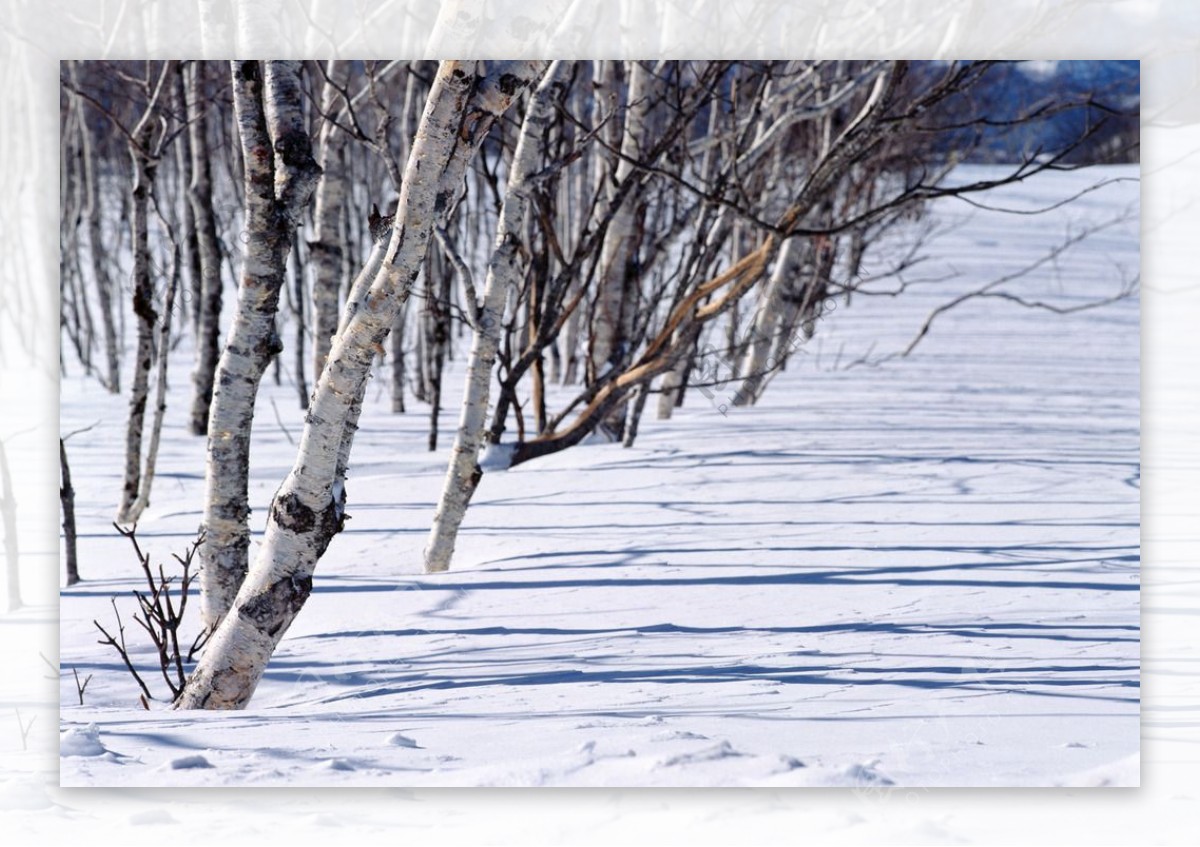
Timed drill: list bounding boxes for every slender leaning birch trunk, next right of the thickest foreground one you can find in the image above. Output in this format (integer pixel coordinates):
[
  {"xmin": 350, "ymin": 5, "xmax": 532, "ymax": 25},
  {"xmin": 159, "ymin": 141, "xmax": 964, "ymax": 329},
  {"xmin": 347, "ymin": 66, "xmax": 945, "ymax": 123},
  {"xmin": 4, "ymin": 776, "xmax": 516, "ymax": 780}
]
[{"xmin": 425, "ymin": 66, "xmax": 557, "ymax": 573}]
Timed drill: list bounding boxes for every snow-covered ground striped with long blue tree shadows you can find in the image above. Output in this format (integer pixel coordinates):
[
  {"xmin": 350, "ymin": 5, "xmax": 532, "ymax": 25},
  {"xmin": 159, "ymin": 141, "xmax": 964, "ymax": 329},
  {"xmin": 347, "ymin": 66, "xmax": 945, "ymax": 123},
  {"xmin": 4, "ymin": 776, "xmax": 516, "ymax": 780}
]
[{"xmin": 60, "ymin": 168, "xmax": 1139, "ymax": 791}]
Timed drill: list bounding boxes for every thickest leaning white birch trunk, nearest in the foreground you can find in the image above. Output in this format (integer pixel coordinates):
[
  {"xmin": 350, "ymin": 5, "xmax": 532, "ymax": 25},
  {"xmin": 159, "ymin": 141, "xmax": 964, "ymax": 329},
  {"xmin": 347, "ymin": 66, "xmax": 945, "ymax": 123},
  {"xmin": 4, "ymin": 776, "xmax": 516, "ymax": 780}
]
[{"xmin": 176, "ymin": 61, "xmax": 545, "ymax": 709}]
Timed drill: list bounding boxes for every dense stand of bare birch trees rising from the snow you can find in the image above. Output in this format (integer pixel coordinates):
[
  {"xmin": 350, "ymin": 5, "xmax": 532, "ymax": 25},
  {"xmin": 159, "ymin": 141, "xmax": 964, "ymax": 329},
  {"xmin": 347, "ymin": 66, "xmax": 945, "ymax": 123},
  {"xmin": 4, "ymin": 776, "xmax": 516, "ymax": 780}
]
[{"xmin": 60, "ymin": 60, "xmax": 1138, "ymax": 709}]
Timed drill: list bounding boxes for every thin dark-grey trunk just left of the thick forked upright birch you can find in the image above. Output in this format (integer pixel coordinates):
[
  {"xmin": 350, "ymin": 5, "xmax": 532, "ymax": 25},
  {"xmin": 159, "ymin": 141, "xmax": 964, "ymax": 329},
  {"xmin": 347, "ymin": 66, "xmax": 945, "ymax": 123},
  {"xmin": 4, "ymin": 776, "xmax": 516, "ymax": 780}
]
[{"xmin": 186, "ymin": 62, "xmax": 222, "ymax": 435}]
